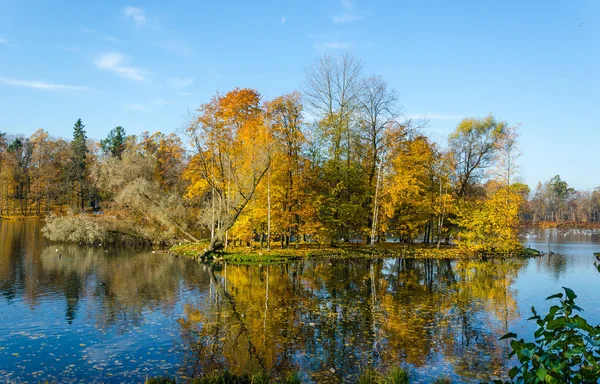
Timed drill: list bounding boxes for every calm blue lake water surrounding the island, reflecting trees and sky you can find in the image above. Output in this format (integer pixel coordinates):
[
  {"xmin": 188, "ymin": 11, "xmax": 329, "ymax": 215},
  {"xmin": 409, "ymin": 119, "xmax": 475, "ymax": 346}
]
[{"xmin": 0, "ymin": 222, "xmax": 600, "ymax": 383}]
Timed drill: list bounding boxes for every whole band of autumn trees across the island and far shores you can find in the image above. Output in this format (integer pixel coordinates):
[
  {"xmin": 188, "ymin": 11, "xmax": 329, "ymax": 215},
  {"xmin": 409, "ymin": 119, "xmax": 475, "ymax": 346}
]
[{"xmin": 0, "ymin": 55, "xmax": 600, "ymax": 251}]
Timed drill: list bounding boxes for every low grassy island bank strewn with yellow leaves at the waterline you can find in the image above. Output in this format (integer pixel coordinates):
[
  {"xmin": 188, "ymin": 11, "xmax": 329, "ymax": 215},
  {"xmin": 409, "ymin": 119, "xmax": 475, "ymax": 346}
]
[{"xmin": 169, "ymin": 240, "xmax": 542, "ymax": 264}]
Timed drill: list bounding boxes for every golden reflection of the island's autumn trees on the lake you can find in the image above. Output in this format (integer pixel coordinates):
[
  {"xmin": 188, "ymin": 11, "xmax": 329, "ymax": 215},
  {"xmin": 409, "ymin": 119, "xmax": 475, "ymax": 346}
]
[{"xmin": 180, "ymin": 258, "xmax": 523, "ymax": 382}]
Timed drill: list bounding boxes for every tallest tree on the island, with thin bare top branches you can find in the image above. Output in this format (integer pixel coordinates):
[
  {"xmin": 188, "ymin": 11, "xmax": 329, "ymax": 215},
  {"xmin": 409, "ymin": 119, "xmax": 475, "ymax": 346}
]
[{"xmin": 304, "ymin": 54, "xmax": 368, "ymax": 241}]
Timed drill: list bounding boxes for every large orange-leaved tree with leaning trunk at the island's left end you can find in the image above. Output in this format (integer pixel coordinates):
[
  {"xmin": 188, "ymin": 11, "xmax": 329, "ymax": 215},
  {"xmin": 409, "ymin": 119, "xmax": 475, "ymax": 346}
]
[{"xmin": 185, "ymin": 89, "xmax": 270, "ymax": 254}]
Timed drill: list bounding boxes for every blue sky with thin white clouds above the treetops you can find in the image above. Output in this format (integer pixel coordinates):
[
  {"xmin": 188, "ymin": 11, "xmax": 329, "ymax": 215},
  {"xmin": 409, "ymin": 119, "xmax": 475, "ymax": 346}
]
[{"xmin": 0, "ymin": 0, "xmax": 600, "ymax": 190}]
